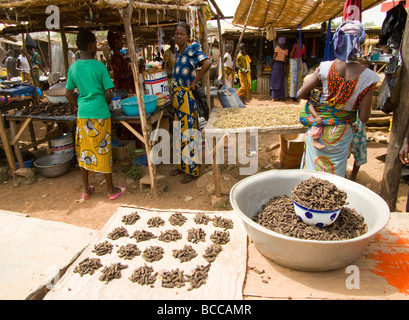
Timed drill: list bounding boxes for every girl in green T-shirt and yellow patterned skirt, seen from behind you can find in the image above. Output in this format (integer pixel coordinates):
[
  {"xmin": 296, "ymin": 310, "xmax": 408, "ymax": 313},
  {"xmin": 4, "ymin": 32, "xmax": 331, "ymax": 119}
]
[{"xmin": 65, "ymin": 30, "xmax": 126, "ymax": 200}]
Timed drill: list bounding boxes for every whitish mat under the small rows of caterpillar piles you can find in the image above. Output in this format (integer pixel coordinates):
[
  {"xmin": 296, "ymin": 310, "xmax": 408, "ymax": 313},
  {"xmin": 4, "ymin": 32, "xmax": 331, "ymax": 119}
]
[{"xmin": 45, "ymin": 206, "xmax": 247, "ymax": 300}]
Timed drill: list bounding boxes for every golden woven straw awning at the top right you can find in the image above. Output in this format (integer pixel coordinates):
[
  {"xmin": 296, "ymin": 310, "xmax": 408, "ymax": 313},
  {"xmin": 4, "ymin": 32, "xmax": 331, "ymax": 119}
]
[{"xmin": 233, "ymin": 0, "xmax": 385, "ymax": 29}]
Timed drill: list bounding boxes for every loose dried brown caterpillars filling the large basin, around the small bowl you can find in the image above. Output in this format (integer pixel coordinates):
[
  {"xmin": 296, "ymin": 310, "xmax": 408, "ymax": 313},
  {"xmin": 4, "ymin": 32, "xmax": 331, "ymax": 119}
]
[{"xmin": 253, "ymin": 196, "xmax": 368, "ymax": 241}]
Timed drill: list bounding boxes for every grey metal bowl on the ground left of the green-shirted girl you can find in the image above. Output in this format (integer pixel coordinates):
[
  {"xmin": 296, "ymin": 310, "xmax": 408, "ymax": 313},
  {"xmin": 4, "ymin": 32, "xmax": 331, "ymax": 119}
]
[{"xmin": 34, "ymin": 154, "xmax": 72, "ymax": 178}]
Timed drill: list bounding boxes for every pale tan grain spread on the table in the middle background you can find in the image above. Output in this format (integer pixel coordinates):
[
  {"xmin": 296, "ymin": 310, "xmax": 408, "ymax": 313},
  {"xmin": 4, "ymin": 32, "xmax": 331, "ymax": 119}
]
[{"xmin": 213, "ymin": 106, "xmax": 301, "ymax": 129}]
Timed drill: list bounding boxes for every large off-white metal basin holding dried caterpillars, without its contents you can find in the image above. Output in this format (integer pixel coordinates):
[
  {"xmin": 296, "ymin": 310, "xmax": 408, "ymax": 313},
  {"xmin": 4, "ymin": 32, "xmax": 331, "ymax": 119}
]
[{"xmin": 230, "ymin": 169, "xmax": 390, "ymax": 271}]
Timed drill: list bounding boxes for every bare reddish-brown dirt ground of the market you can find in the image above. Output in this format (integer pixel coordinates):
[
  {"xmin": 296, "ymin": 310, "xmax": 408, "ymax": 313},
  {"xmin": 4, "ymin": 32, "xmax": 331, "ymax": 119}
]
[{"xmin": 0, "ymin": 96, "xmax": 409, "ymax": 230}]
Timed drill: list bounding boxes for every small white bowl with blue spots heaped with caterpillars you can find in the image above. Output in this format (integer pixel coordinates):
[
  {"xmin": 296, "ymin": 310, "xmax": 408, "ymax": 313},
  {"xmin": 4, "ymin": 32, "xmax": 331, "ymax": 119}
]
[{"xmin": 293, "ymin": 200, "xmax": 341, "ymax": 228}]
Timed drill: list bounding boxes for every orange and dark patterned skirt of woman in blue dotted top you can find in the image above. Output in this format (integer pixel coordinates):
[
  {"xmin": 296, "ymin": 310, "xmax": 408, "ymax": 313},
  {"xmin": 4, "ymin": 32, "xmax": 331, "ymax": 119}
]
[{"xmin": 172, "ymin": 86, "xmax": 202, "ymax": 176}]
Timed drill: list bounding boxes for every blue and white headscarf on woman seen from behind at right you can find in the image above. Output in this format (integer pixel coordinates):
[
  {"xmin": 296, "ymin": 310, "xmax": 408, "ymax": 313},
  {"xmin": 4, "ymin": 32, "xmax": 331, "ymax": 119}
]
[{"xmin": 332, "ymin": 20, "xmax": 365, "ymax": 63}]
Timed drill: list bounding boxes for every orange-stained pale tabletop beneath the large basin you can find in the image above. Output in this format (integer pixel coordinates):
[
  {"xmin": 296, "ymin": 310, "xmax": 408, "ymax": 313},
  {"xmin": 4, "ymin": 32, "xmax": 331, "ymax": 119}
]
[{"xmin": 243, "ymin": 212, "xmax": 409, "ymax": 300}]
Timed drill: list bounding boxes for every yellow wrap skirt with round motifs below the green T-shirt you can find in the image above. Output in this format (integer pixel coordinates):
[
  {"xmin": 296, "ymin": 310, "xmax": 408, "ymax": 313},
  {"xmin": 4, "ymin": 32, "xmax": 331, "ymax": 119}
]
[{"xmin": 75, "ymin": 118, "xmax": 112, "ymax": 173}]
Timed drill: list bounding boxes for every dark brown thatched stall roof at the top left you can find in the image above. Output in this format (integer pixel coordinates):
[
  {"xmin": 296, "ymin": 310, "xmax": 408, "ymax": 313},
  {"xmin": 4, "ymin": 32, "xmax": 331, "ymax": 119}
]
[{"xmin": 0, "ymin": 0, "xmax": 208, "ymax": 43}]
